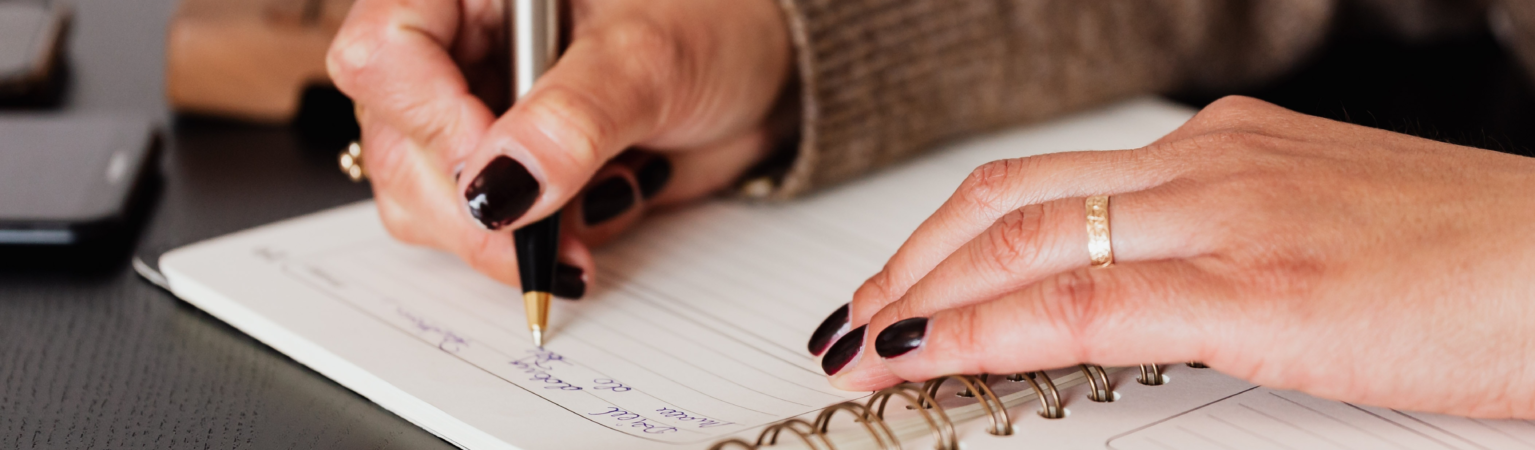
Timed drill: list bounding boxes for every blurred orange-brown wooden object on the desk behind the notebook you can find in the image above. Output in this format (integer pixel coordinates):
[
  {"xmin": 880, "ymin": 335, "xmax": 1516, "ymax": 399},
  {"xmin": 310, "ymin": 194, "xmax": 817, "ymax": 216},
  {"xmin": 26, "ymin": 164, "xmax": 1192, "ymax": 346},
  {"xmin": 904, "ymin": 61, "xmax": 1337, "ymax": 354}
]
[{"xmin": 166, "ymin": 0, "xmax": 353, "ymax": 123}]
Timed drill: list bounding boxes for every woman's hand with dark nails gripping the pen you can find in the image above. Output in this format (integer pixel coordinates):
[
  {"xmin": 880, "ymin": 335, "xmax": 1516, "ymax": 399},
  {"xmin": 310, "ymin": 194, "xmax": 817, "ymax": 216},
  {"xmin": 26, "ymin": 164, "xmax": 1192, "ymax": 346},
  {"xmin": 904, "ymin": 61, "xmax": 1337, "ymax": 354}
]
[{"xmin": 327, "ymin": 0, "xmax": 792, "ymax": 291}]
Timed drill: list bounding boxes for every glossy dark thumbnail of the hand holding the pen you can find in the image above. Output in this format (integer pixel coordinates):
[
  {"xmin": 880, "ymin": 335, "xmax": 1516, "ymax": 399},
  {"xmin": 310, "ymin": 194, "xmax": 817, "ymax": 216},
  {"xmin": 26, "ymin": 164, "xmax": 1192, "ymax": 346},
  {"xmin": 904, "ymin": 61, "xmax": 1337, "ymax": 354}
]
[{"xmin": 464, "ymin": 157, "xmax": 542, "ymax": 230}]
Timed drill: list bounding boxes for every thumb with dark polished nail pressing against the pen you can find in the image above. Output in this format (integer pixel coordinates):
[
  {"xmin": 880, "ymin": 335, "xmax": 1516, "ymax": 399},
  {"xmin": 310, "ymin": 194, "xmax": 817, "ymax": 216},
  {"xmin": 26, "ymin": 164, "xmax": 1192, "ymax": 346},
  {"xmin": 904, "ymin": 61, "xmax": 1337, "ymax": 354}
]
[{"xmin": 459, "ymin": 25, "xmax": 669, "ymax": 229}]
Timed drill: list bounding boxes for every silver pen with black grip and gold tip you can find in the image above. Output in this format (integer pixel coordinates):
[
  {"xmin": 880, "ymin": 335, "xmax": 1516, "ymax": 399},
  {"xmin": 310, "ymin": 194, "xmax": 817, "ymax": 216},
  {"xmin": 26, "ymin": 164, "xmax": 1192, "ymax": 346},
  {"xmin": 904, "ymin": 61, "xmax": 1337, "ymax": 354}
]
[{"xmin": 507, "ymin": 0, "xmax": 560, "ymax": 347}]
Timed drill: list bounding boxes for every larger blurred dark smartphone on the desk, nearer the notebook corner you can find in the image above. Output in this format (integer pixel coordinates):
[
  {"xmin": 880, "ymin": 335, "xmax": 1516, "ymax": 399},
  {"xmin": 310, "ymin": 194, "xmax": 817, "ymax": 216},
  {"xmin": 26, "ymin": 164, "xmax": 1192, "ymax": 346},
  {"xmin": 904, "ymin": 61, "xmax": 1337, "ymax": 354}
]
[{"xmin": 0, "ymin": 115, "xmax": 158, "ymax": 247}]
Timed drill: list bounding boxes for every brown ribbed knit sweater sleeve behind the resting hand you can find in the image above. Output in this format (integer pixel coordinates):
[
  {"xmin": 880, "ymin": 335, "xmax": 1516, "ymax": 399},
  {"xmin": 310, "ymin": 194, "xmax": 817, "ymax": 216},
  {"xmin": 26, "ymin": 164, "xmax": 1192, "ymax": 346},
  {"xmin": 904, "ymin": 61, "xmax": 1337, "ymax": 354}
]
[{"xmin": 767, "ymin": 0, "xmax": 1535, "ymax": 198}]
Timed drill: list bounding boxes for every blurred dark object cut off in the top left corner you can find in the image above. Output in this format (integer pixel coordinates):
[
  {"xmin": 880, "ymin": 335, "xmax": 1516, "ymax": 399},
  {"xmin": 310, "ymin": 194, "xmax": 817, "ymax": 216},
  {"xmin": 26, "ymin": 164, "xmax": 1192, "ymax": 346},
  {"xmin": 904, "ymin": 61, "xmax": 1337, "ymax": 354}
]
[{"xmin": 0, "ymin": 0, "xmax": 69, "ymax": 98}]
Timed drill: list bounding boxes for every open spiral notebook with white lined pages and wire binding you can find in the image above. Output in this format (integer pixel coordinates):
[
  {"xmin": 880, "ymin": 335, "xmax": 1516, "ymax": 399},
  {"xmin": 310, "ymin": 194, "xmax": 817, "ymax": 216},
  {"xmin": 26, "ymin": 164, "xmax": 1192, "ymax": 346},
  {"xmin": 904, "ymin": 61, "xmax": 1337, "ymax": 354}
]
[{"xmin": 160, "ymin": 100, "xmax": 1535, "ymax": 450}]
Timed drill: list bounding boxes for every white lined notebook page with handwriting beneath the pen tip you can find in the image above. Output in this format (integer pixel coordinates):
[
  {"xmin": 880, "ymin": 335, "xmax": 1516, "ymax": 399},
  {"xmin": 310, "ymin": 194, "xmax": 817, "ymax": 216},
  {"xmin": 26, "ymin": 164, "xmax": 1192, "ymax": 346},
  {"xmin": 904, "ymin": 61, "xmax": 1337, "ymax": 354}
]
[{"xmin": 161, "ymin": 100, "xmax": 1190, "ymax": 448}]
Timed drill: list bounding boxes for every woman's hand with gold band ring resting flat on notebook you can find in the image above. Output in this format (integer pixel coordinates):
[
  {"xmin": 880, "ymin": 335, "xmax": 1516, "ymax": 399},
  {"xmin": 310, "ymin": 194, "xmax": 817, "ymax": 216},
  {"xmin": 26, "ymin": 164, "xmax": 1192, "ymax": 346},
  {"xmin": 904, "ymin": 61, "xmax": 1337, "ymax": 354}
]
[{"xmin": 810, "ymin": 97, "xmax": 1535, "ymax": 418}]
